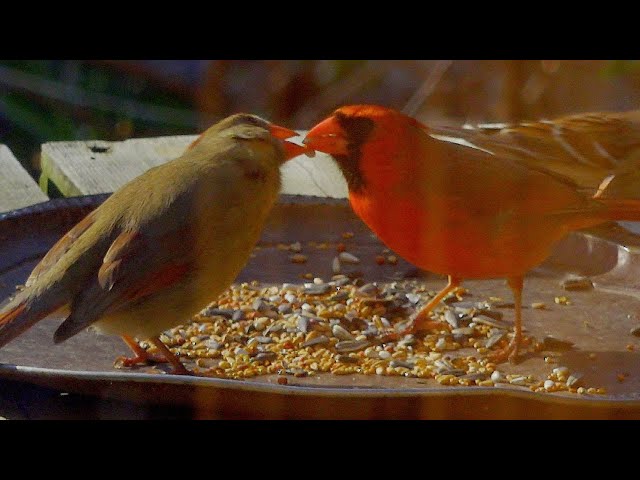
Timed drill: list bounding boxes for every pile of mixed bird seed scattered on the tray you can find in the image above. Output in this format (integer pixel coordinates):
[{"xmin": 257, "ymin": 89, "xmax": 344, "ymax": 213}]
[{"xmin": 142, "ymin": 274, "xmax": 606, "ymax": 394}]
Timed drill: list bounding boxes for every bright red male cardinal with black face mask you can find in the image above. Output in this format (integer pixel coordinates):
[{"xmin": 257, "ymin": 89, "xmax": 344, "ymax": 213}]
[{"xmin": 304, "ymin": 105, "xmax": 640, "ymax": 361}]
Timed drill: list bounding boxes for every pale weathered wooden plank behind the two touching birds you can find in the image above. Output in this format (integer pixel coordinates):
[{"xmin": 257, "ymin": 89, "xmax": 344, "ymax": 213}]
[{"xmin": 41, "ymin": 135, "xmax": 347, "ymax": 198}]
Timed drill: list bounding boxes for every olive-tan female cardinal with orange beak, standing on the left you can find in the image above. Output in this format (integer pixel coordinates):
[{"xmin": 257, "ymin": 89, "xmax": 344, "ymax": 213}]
[{"xmin": 0, "ymin": 114, "xmax": 308, "ymax": 373}]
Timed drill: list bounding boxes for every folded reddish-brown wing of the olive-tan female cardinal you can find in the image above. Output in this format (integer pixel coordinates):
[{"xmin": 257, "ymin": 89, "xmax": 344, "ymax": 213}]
[{"xmin": 54, "ymin": 223, "xmax": 193, "ymax": 343}]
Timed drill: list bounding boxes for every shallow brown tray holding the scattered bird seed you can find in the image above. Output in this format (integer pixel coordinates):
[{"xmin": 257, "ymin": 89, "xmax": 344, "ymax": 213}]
[{"xmin": 0, "ymin": 195, "xmax": 640, "ymax": 413}]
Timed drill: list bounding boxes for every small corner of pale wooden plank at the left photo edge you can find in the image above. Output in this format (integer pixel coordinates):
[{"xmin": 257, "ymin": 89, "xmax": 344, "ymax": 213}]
[{"xmin": 0, "ymin": 145, "xmax": 48, "ymax": 213}]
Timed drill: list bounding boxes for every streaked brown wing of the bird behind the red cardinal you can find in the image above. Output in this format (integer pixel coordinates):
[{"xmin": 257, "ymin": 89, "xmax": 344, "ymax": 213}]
[{"xmin": 430, "ymin": 110, "xmax": 640, "ymax": 196}]
